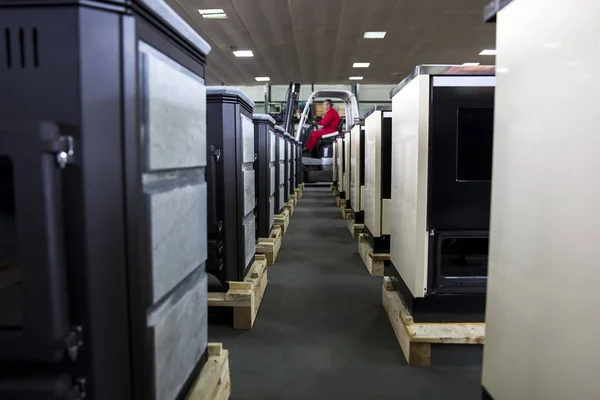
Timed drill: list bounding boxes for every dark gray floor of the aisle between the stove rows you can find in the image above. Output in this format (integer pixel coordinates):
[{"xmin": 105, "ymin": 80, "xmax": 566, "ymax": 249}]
[{"xmin": 209, "ymin": 188, "xmax": 481, "ymax": 400}]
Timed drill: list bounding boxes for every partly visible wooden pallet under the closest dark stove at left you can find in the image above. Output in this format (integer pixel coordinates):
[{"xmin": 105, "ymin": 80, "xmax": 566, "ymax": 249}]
[{"xmin": 186, "ymin": 343, "xmax": 231, "ymax": 400}]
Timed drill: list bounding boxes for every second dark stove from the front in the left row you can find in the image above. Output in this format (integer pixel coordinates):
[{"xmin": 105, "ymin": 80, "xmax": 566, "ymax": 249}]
[{"xmin": 207, "ymin": 86, "xmax": 256, "ymax": 290}]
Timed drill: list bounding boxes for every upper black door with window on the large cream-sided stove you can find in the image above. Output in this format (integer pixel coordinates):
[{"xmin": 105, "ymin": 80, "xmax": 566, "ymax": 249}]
[{"xmin": 427, "ymin": 76, "xmax": 495, "ymax": 230}]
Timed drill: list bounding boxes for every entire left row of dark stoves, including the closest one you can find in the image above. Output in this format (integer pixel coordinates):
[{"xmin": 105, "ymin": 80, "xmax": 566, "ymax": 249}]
[{"xmin": 0, "ymin": 0, "xmax": 302, "ymax": 400}]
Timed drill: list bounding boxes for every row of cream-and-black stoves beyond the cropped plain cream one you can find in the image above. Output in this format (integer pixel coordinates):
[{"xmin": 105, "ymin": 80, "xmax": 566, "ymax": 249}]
[{"xmin": 333, "ymin": 66, "xmax": 495, "ymax": 321}]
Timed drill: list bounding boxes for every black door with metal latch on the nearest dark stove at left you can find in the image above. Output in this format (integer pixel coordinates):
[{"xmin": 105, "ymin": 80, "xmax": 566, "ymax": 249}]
[{"xmin": 0, "ymin": 123, "xmax": 71, "ymax": 362}]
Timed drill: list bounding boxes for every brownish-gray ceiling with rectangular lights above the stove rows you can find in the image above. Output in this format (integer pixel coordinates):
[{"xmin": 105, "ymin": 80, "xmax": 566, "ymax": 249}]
[{"xmin": 167, "ymin": 0, "xmax": 495, "ymax": 85}]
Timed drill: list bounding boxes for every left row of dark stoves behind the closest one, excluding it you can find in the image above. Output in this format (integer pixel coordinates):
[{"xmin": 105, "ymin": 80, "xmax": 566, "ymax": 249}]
[{"xmin": 206, "ymin": 86, "xmax": 302, "ymax": 290}]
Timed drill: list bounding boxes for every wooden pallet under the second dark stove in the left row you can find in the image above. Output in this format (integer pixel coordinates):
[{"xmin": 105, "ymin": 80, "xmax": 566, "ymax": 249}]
[{"xmin": 208, "ymin": 254, "xmax": 267, "ymax": 329}]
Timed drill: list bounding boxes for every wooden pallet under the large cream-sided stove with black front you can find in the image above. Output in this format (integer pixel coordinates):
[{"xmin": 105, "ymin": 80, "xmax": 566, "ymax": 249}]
[{"xmin": 382, "ymin": 276, "xmax": 485, "ymax": 366}]
